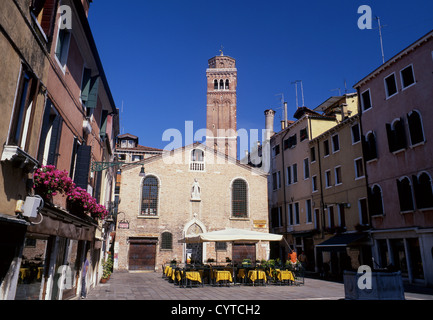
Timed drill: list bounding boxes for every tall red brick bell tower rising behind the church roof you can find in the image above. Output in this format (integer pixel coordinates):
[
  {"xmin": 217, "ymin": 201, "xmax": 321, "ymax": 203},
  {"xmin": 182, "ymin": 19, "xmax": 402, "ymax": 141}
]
[{"xmin": 206, "ymin": 50, "xmax": 237, "ymax": 159}]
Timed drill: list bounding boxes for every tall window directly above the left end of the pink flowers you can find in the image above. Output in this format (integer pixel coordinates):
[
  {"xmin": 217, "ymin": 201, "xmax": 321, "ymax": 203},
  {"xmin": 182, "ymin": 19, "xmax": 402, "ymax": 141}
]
[{"xmin": 38, "ymin": 99, "xmax": 62, "ymax": 166}]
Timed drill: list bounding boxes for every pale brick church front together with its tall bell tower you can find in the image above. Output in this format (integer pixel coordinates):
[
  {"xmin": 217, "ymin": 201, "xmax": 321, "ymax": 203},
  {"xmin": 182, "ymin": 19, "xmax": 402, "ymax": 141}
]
[{"xmin": 114, "ymin": 54, "xmax": 270, "ymax": 271}]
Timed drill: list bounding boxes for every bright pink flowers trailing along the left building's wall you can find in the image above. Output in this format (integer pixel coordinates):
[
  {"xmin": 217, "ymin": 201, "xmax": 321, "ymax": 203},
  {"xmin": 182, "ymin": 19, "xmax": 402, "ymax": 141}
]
[{"xmin": 34, "ymin": 166, "xmax": 108, "ymax": 219}]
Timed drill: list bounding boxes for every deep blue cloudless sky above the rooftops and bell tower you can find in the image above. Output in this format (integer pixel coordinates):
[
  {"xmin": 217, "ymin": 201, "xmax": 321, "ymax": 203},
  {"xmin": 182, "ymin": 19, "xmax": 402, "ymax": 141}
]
[{"xmin": 89, "ymin": 0, "xmax": 433, "ymax": 155}]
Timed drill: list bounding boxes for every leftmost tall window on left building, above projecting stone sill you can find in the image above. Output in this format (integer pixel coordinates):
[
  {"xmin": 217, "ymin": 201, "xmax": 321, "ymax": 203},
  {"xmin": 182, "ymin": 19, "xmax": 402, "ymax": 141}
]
[{"xmin": 8, "ymin": 69, "xmax": 39, "ymax": 151}]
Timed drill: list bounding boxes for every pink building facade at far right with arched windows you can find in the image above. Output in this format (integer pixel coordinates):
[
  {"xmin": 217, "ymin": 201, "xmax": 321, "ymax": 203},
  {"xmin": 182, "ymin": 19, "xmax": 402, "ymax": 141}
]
[{"xmin": 354, "ymin": 32, "xmax": 433, "ymax": 286}]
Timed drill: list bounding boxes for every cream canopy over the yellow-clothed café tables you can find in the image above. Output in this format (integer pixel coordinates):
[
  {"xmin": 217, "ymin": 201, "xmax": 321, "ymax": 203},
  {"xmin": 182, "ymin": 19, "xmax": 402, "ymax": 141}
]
[{"xmin": 182, "ymin": 229, "xmax": 283, "ymax": 243}]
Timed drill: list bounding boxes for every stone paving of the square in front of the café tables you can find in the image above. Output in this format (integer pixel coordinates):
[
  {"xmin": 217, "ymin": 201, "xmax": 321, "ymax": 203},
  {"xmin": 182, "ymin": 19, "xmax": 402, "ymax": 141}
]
[{"xmin": 86, "ymin": 272, "xmax": 433, "ymax": 300}]
